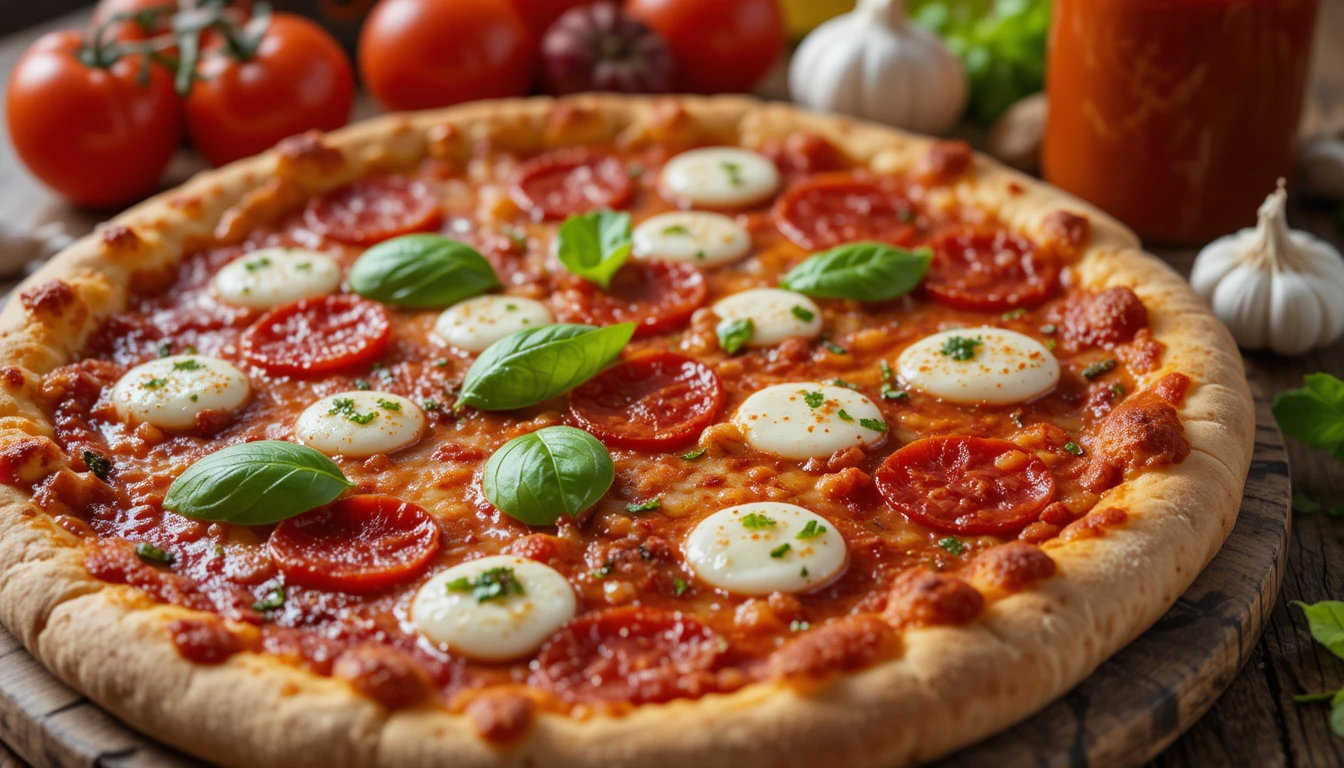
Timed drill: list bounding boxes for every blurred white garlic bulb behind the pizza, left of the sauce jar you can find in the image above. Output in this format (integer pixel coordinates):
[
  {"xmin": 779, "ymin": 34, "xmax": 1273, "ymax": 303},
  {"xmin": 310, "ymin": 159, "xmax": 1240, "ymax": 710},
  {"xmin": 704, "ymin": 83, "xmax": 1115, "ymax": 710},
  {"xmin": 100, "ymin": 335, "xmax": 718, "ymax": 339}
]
[{"xmin": 789, "ymin": 0, "xmax": 966, "ymax": 135}]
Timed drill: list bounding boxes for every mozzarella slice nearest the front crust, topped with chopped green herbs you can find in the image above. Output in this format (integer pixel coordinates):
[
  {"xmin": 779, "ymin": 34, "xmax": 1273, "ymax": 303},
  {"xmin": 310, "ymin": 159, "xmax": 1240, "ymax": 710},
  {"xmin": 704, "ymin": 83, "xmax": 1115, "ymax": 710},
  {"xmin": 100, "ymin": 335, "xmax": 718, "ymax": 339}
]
[{"xmin": 410, "ymin": 555, "xmax": 578, "ymax": 660}]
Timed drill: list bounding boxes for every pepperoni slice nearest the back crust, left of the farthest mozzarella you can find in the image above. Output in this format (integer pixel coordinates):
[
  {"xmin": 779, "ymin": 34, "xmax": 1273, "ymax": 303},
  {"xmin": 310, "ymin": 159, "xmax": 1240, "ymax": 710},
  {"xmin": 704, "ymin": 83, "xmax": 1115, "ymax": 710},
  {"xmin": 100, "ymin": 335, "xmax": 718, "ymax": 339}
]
[{"xmin": 512, "ymin": 149, "xmax": 634, "ymax": 221}]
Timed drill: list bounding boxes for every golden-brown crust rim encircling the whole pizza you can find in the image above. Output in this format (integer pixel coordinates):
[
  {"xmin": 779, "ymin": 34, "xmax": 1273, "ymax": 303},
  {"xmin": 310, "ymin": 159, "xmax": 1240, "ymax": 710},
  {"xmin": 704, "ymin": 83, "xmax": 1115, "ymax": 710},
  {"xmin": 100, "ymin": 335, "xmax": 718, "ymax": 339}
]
[{"xmin": 0, "ymin": 97, "xmax": 1254, "ymax": 768}]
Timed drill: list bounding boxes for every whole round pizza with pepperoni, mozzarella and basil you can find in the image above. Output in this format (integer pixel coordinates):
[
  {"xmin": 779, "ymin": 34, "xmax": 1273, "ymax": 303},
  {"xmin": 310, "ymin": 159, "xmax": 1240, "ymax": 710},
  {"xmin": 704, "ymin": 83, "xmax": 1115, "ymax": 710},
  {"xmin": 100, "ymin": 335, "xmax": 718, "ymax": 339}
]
[{"xmin": 0, "ymin": 97, "xmax": 1254, "ymax": 768}]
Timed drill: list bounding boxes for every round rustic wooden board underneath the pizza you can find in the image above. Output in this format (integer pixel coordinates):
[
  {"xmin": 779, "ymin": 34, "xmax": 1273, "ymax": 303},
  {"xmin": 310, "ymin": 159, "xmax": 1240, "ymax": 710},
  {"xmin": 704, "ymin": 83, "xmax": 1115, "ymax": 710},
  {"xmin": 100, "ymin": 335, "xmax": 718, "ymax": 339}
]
[{"xmin": 0, "ymin": 371, "xmax": 1292, "ymax": 768}]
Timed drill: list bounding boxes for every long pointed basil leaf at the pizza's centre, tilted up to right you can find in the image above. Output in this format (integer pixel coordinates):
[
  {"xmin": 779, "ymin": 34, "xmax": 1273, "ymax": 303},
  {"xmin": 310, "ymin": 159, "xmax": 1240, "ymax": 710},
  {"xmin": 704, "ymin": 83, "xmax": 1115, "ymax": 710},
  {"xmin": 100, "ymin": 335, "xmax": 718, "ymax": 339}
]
[{"xmin": 454, "ymin": 323, "xmax": 634, "ymax": 410}]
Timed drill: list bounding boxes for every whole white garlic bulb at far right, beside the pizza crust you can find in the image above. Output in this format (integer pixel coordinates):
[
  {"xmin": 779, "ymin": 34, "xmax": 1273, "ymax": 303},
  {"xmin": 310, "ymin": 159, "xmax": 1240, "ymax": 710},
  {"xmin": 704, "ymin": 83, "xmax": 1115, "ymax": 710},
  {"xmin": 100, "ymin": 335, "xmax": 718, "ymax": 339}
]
[{"xmin": 1189, "ymin": 179, "xmax": 1344, "ymax": 355}]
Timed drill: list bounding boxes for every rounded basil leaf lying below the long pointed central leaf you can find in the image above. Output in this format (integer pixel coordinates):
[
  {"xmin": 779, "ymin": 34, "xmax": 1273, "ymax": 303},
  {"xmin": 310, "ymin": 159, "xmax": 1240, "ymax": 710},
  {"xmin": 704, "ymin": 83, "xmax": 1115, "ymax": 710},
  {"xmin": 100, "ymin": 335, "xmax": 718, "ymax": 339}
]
[{"xmin": 481, "ymin": 426, "xmax": 616, "ymax": 526}]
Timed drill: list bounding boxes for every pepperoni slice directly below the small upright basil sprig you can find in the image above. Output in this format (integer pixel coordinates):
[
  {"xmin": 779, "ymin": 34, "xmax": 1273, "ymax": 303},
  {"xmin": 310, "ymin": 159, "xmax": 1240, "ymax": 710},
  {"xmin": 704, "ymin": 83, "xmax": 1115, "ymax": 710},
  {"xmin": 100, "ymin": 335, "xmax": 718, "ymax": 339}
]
[{"xmin": 558, "ymin": 260, "xmax": 710, "ymax": 336}]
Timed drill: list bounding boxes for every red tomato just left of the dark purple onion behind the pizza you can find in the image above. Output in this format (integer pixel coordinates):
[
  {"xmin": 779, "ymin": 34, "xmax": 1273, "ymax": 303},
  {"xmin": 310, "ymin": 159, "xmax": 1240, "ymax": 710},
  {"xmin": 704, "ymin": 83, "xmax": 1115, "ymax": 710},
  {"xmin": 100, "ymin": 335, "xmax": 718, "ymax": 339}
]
[{"xmin": 359, "ymin": 0, "xmax": 536, "ymax": 109}]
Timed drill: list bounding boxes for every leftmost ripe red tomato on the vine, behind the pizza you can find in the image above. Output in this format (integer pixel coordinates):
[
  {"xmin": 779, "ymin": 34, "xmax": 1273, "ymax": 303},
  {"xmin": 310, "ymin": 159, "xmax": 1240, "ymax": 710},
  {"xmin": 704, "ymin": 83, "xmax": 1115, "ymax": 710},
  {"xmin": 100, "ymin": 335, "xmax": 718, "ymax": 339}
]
[{"xmin": 5, "ymin": 30, "xmax": 181, "ymax": 207}]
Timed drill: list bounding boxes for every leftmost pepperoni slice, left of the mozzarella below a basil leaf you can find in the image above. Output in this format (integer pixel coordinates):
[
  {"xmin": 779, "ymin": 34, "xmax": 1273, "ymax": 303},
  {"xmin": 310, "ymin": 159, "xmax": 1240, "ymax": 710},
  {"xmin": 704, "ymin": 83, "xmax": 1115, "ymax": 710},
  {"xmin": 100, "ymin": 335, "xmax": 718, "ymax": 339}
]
[{"xmin": 238, "ymin": 296, "xmax": 392, "ymax": 377}]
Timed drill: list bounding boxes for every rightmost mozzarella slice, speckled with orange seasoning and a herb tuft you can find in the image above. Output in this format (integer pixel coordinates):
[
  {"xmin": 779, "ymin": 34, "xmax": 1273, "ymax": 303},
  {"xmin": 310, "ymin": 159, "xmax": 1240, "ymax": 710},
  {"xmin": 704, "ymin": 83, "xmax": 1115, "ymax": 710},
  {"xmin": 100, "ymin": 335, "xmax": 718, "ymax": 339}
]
[{"xmin": 896, "ymin": 328, "xmax": 1059, "ymax": 405}]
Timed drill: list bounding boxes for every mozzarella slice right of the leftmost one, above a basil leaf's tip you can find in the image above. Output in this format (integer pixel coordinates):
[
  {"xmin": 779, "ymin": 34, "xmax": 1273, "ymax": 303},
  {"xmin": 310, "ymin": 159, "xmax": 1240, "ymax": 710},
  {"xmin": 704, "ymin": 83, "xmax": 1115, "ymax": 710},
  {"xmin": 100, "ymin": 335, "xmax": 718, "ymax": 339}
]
[{"xmin": 294, "ymin": 390, "xmax": 425, "ymax": 459}]
